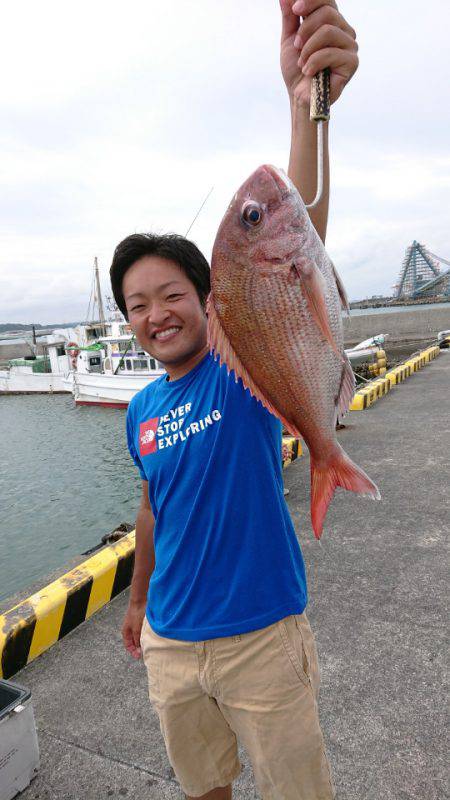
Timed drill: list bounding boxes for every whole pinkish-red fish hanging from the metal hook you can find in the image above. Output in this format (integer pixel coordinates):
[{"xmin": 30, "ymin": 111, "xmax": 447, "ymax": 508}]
[{"xmin": 207, "ymin": 164, "xmax": 380, "ymax": 539}]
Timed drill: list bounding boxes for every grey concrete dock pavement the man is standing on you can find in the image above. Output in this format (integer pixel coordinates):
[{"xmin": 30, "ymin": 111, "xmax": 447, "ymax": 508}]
[{"xmin": 8, "ymin": 352, "xmax": 450, "ymax": 800}]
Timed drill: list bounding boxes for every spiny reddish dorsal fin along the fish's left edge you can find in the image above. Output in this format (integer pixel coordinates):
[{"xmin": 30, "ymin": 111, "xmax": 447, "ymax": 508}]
[{"xmin": 207, "ymin": 293, "xmax": 300, "ymax": 438}]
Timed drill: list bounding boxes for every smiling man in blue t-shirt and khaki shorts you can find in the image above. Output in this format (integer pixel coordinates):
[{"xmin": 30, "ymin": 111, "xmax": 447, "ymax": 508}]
[{"xmin": 111, "ymin": 0, "xmax": 358, "ymax": 800}]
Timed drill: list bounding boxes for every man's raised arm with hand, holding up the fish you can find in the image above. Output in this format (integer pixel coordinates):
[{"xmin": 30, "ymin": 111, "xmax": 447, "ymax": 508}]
[{"xmin": 280, "ymin": 0, "xmax": 358, "ymax": 242}]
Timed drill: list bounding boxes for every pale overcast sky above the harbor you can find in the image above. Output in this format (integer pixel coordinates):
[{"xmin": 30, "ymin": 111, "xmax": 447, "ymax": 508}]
[{"xmin": 0, "ymin": 0, "xmax": 450, "ymax": 323}]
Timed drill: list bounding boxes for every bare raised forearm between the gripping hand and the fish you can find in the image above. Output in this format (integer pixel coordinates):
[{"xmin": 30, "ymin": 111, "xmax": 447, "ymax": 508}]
[{"xmin": 288, "ymin": 98, "xmax": 330, "ymax": 242}]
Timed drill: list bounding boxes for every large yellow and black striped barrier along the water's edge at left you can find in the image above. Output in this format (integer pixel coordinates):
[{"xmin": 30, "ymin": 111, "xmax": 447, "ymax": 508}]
[{"xmin": 0, "ymin": 531, "xmax": 135, "ymax": 678}]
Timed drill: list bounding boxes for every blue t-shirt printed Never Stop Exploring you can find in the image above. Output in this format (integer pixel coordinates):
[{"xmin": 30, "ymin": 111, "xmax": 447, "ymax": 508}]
[{"xmin": 127, "ymin": 354, "xmax": 307, "ymax": 641}]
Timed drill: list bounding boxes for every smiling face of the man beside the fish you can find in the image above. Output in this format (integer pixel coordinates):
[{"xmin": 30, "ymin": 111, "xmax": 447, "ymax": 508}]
[{"xmin": 122, "ymin": 256, "xmax": 207, "ymax": 365}]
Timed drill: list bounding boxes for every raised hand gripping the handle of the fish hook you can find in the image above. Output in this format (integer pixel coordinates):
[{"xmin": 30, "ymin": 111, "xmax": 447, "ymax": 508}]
[{"xmin": 280, "ymin": 0, "xmax": 358, "ymax": 108}]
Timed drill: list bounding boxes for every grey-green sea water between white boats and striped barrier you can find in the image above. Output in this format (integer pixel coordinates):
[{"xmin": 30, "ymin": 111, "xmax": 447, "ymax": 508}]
[{"xmin": 0, "ymin": 394, "xmax": 141, "ymax": 600}]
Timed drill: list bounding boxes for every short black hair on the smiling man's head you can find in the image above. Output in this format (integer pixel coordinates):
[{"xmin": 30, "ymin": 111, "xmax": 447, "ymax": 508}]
[{"xmin": 109, "ymin": 233, "xmax": 210, "ymax": 319}]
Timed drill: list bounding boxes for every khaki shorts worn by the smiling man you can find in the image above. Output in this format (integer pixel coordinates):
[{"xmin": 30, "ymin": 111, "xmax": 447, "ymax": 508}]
[{"xmin": 141, "ymin": 613, "xmax": 334, "ymax": 800}]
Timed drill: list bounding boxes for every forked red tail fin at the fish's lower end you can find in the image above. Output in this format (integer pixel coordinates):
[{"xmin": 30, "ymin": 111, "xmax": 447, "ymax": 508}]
[{"xmin": 311, "ymin": 445, "xmax": 380, "ymax": 539}]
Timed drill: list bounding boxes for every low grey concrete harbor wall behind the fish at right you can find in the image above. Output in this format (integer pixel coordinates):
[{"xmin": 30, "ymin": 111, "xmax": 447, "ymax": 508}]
[{"xmin": 343, "ymin": 303, "xmax": 450, "ymax": 347}]
